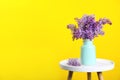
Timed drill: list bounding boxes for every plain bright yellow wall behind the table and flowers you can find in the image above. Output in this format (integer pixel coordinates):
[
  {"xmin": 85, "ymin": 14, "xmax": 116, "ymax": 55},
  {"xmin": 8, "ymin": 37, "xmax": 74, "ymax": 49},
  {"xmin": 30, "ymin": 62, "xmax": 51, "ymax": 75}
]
[{"xmin": 0, "ymin": 0, "xmax": 120, "ymax": 80}]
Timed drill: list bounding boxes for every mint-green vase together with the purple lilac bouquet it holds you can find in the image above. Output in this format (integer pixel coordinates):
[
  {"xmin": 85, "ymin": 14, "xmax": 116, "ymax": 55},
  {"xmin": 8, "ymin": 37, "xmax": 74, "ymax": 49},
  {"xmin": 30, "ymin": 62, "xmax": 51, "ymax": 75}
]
[{"xmin": 67, "ymin": 15, "xmax": 112, "ymax": 65}]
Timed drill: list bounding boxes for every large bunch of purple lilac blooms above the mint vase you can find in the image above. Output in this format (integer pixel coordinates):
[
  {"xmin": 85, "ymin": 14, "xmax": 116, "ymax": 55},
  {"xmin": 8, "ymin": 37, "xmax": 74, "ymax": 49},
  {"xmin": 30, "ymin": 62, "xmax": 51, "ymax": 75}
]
[{"xmin": 67, "ymin": 15, "xmax": 112, "ymax": 40}]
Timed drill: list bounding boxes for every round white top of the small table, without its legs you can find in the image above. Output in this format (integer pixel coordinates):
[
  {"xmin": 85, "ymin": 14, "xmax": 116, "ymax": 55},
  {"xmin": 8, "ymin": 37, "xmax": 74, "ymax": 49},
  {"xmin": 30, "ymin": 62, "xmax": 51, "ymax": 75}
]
[{"xmin": 60, "ymin": 58, "xmax": 114, "ymax": 72}]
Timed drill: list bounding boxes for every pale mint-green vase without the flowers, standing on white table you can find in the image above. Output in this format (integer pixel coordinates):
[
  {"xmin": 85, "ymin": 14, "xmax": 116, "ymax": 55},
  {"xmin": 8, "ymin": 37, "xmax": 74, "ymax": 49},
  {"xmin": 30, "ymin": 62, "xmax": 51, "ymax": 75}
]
[{"xmin": 81, "ymin": 39, "xmax": 96, "ymax": 66}]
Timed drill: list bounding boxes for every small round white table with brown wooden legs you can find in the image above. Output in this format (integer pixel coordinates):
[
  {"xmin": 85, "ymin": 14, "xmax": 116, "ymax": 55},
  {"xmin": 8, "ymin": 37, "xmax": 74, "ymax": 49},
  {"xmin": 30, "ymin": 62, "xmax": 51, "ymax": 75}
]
[{"xmin": 60, "ymin": 59, "xmax": 114, "ymax": 80}]
